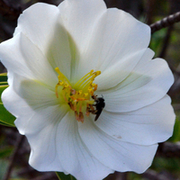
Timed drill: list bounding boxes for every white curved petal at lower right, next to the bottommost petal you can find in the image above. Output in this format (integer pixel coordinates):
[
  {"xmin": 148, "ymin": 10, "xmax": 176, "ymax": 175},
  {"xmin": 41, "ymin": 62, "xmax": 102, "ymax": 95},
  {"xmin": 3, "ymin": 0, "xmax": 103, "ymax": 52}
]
[{"xmin": 79, "ymin": 119, "xmax": 157, "ymax": 173}]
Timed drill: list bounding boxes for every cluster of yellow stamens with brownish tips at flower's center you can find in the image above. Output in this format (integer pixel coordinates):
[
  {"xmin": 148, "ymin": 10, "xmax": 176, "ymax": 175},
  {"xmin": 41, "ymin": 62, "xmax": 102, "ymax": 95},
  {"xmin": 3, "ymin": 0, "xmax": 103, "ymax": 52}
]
[{"xmin": 55, "ymin": 67, "xmax": 101, "ymax": 122}]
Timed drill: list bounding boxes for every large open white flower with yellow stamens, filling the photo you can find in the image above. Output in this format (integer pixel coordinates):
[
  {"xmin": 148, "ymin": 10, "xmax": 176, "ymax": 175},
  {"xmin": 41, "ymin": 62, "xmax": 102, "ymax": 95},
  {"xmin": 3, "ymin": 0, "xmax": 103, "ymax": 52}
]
[{"xmin": 0, "ymin": 0, "xmax": 175, "ymax": 180}]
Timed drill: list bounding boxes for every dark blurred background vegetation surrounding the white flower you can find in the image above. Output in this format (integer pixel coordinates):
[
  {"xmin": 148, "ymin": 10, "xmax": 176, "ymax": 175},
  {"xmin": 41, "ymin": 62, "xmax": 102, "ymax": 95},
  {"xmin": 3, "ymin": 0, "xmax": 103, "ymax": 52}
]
[{"xmin": 0, "ymin": 0, "xmax": 180, "ymax": 180}]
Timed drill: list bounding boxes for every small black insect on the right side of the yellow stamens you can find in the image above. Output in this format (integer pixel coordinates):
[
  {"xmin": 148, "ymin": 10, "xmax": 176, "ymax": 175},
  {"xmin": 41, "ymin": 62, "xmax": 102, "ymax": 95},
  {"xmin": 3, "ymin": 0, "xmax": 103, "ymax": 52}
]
[{"xmin": 91, "ymin": 96, "xmax": 105, "ymax": 121}]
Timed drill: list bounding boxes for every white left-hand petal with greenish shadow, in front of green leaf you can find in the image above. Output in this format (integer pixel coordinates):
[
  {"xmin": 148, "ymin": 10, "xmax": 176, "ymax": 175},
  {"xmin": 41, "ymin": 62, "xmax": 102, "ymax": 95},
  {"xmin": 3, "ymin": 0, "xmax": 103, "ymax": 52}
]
[{"xmin": 2, "ymin": 74, "xmax": 69, "ymax": 134}]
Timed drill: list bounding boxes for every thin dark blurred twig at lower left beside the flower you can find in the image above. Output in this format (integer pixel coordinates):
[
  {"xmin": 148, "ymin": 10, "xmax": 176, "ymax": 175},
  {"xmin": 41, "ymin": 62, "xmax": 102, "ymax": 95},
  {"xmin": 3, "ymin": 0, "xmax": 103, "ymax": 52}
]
[{"xmin": 3, "ymin": 135, "xmax": 24, "ymax": 180}]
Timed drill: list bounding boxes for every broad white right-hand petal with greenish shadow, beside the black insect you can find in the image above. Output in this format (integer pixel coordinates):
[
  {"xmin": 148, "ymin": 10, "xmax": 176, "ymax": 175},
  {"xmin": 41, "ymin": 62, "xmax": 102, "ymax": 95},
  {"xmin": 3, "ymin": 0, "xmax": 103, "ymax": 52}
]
[{"xmin": 103, "ymin": 57, "xmax": 174, "ymax": 112}]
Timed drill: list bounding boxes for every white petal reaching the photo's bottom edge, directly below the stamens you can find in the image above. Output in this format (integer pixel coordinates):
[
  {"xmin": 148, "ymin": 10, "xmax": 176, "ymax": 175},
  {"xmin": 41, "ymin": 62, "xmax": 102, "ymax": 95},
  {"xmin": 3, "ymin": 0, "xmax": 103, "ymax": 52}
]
[{"xmin": 55, "ymin": 112, "xmax": 113, "ymax": 180}]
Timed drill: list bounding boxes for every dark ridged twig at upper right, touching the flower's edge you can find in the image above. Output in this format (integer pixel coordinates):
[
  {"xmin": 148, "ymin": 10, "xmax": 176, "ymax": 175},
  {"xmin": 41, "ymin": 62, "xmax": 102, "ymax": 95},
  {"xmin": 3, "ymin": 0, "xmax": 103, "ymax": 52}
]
[{"xmin": 150, "ymin": 11, "xmax": 180, "ymax": 34}]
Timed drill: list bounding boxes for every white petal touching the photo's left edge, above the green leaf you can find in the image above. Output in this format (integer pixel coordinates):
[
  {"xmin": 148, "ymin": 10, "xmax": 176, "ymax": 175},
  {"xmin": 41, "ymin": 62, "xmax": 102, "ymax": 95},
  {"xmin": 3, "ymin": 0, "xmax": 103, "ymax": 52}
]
[{"xmin": 0, "ymin": 33, "xmax": 58, "ymax": 88}]
